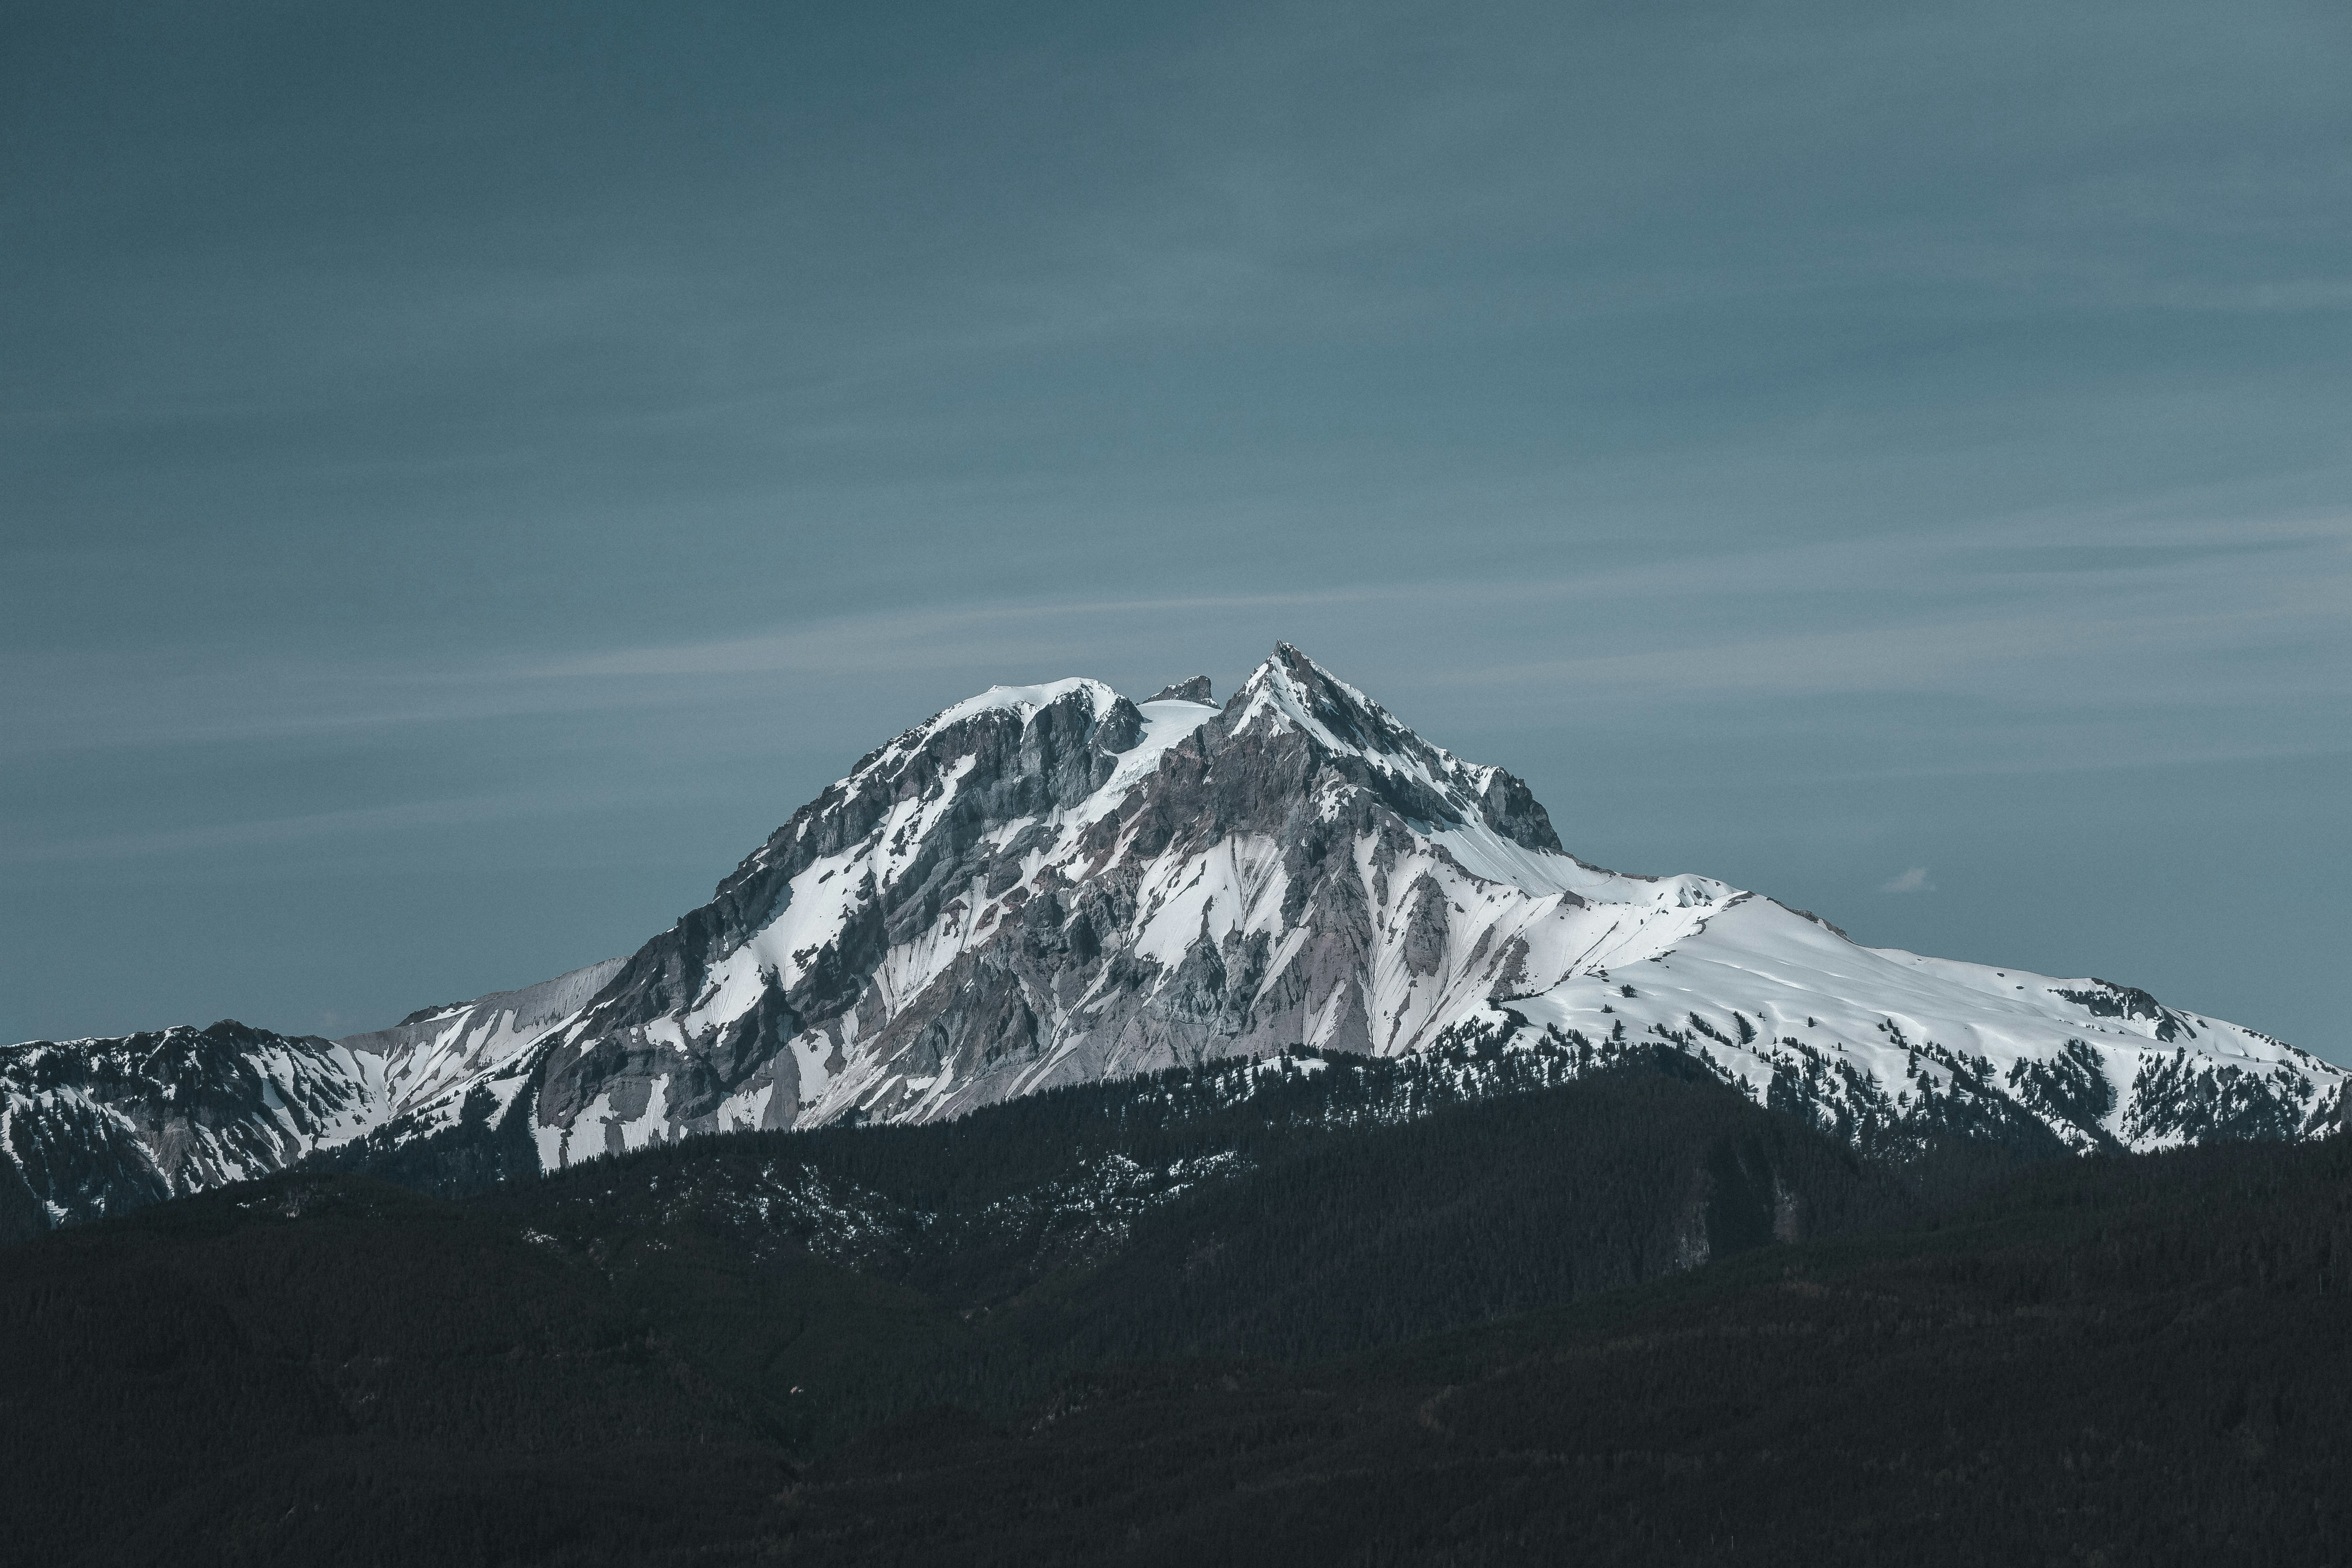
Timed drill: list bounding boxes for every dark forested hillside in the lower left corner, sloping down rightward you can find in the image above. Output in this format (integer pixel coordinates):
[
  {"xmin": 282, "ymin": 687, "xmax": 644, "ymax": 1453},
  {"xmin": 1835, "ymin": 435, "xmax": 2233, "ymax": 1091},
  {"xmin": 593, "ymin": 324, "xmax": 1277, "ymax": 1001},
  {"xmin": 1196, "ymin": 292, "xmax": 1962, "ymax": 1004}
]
[{"xmin": 0, "ymin": 1178, "xmax": 790, "ymax": 1564}]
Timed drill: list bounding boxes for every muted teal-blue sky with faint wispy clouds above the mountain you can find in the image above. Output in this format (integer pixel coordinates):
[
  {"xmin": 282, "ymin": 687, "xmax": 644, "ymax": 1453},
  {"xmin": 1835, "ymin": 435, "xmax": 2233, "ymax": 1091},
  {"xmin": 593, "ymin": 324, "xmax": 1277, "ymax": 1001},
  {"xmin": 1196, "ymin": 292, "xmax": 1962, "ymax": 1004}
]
[{"xmin": 0, "ymin": 0, "xmax": 2352, "ymax": 1060}]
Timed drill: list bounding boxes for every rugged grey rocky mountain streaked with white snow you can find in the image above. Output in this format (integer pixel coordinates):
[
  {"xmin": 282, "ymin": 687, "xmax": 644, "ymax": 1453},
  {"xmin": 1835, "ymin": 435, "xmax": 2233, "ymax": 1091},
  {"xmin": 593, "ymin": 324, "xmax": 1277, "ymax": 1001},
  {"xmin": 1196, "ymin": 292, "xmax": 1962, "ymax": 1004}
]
[{"xmin": 0, "ymin": 644, "xmax": 2348, "ymax": 1223}]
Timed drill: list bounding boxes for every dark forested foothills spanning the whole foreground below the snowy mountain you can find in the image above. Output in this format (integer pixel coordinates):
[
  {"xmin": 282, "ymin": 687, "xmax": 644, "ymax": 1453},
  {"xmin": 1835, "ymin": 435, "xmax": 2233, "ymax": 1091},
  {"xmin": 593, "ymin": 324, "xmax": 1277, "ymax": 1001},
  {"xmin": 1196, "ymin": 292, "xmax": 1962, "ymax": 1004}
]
[{"xmin": 0, "ymin": 1056, "xmax": 2352, "ymax": 1564}]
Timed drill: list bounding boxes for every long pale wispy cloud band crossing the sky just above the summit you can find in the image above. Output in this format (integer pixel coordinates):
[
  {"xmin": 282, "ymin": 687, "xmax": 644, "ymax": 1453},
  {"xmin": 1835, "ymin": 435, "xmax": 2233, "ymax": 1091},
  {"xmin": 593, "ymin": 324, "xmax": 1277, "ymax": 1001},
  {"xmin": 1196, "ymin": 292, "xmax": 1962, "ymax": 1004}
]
[{"xmin": 4, "ymin": 520, "xmax": 2352, "ymax": 757}]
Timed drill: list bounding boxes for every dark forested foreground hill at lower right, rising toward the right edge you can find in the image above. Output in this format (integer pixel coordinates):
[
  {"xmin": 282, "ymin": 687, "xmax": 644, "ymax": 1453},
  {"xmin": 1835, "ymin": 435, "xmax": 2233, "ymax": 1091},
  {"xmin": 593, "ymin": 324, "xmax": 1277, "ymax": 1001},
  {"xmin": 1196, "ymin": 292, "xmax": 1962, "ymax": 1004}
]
[{"xmin": 795, "ymin": 1140, "xmax": 2352, "ymax": 1566}]
